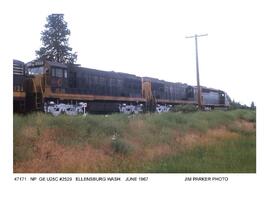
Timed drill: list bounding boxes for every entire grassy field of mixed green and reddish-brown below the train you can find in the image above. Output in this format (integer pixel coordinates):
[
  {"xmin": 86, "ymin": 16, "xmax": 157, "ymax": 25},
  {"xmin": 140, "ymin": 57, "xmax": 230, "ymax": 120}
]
[{"xmin": 13, "ymin": 110, "xmax": 256, "ymax": 172}]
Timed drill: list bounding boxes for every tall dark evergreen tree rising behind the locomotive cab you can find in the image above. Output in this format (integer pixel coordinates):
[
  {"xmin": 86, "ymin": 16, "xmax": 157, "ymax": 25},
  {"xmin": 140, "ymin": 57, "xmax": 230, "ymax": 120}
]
[{"xmin": 36, "ymin": 14, "xmax": 77, "ymax": 64}]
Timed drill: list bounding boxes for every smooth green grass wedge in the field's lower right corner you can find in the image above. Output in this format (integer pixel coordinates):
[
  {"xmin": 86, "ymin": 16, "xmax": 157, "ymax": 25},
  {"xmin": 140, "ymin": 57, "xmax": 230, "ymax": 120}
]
[{"xmin": 142, "ymin": 133, "xmax": 256, "ymax": 173}]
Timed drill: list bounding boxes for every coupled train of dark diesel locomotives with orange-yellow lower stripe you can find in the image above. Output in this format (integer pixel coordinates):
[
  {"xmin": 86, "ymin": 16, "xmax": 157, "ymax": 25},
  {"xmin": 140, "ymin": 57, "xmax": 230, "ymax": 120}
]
[{"xmin": 13, "ymin": 60, "xmax": 230, "ymax": 115}]
